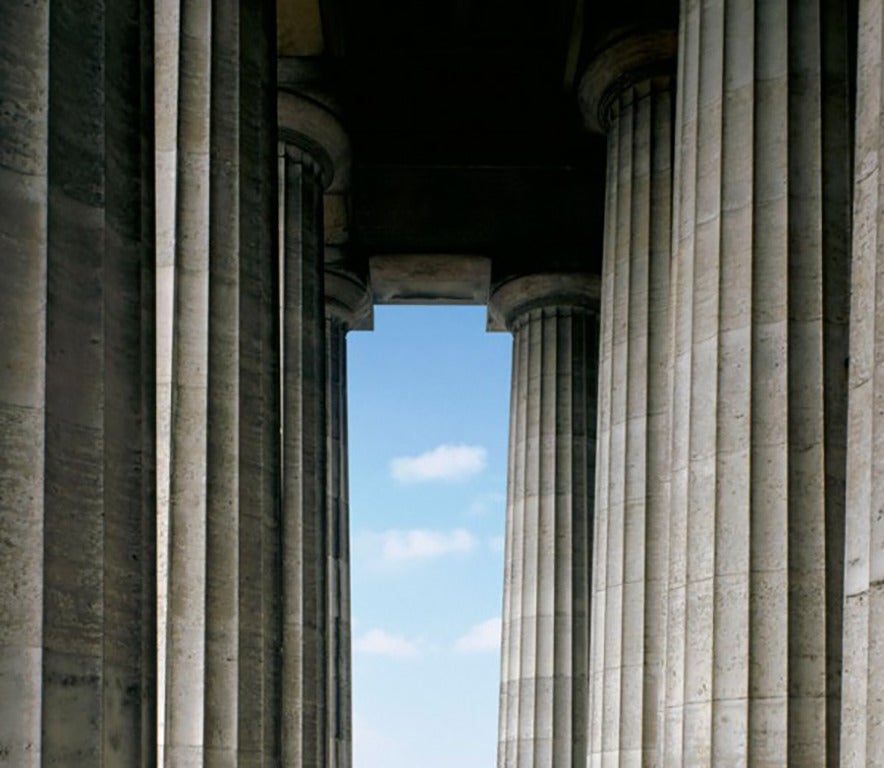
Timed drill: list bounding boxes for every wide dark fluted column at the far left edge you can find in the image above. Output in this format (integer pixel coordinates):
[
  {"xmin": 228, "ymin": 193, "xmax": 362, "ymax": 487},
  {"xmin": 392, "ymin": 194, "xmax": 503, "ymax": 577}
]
[{"xmin": 0, "ymin": 0, "xmax": 156, "ymax": 768}]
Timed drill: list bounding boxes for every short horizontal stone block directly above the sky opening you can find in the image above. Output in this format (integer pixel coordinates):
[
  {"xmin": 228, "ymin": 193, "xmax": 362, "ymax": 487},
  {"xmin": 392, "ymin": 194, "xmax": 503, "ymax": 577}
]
[{"xmin": 369, "ymin": 253, "xmax": 491, "ymax": 304}]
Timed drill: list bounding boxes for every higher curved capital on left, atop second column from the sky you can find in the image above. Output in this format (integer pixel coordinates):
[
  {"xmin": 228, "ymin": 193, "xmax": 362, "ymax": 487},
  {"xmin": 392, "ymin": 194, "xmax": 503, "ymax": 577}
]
[{"xmin": 277, "ymin": 89, "xmax": 351, "ymax": 192}]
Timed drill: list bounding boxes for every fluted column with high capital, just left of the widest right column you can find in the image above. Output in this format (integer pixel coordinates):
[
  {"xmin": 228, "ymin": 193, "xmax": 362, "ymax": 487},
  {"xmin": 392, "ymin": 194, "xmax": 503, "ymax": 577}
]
[{"xmin": 581, "ymin": 32, "xmax": 676, "ymax": 766}]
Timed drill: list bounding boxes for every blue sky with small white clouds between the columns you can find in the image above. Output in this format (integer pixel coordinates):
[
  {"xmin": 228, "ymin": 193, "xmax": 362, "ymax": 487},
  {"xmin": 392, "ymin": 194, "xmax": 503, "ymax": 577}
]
[{"xmin": 347, "ymin": 307, "xmax": 512, "ymax": 768}]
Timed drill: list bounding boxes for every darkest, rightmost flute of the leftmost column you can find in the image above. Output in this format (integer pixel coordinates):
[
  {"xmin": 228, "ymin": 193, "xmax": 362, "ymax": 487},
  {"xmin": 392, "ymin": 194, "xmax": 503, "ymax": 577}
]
[{"xmin": 101, "ymin": 2, "xmax": 156, "ymax": 766}]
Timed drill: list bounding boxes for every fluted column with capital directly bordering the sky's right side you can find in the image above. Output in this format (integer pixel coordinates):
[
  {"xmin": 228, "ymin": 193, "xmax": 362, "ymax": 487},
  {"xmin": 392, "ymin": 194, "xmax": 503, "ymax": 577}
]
[{"xmin": 490, "ymin": 274, "xmax": 599, "ymax": 768}]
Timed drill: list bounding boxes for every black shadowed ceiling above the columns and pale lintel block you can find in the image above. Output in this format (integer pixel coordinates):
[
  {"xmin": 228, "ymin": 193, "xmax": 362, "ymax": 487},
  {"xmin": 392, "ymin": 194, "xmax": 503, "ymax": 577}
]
[{"xmin": 278, "ymin": 0, "xmax": 672, "ymax": 288}]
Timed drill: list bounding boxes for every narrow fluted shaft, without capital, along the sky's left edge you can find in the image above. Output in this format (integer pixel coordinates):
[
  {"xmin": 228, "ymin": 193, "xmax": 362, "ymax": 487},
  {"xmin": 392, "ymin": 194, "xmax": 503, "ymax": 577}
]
[{"xmin": 325, "ymin": 311, "xmax": 353, "ymax": 768}]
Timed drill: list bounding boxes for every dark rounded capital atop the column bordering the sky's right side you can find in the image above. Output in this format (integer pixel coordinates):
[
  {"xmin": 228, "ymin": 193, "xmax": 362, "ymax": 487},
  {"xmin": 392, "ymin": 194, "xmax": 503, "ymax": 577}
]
[{"xmin": 488, "ymin": 272, "xmax": 601, "ymax": 331}]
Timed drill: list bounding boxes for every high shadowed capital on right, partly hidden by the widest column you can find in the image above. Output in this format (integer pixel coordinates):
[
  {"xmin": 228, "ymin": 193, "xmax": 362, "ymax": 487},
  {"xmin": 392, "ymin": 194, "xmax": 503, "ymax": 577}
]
[{"xmin": 577, "ymin": 29, "xmax": 678, "ymax": 133}]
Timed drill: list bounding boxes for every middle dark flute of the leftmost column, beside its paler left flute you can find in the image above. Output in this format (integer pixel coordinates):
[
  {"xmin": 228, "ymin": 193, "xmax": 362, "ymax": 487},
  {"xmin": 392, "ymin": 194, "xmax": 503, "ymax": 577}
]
[{"xmin": 41, "ymin": 1, "xmax": 110, "ymax": 765}]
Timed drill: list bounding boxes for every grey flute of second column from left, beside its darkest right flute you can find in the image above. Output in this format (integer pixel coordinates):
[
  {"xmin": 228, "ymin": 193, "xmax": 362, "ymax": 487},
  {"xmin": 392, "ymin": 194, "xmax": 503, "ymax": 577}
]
[{"xmin": 202, "ymin": 0, "xmax": 242, "ymax": 766}]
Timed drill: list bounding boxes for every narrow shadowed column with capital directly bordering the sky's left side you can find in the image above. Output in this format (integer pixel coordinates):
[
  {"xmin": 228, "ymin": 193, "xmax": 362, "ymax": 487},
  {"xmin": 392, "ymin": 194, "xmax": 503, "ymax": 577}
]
[{"xmin": 325, "ymin": 266, "xmax": 372, "ymax": 768}]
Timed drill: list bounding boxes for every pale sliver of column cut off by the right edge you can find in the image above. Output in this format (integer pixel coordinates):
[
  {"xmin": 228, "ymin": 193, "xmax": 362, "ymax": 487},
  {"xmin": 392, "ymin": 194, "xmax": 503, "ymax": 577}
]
[{"xmin": 841, "ymin": 0, "xmax": 884, "ymax": 768}]
